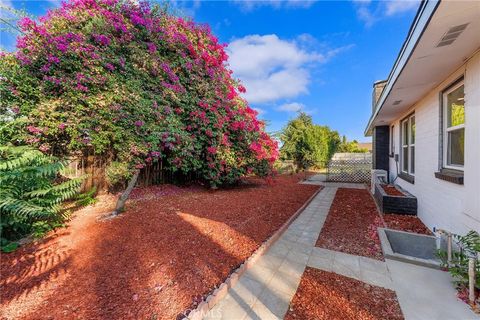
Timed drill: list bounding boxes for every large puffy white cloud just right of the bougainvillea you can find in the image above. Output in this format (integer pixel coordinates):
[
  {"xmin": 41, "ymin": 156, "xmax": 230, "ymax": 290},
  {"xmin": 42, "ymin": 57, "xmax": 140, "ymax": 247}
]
[{"xmin": 227, "ymin": 34, "xmax": 350, "ymax": 103}]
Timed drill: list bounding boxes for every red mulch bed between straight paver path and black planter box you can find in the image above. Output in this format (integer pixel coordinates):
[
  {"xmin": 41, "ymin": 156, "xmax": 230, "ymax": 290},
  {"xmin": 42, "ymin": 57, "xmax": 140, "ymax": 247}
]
[{"xmin": 316, "ymin": 188, "xmax": 383, "ymax": 260}]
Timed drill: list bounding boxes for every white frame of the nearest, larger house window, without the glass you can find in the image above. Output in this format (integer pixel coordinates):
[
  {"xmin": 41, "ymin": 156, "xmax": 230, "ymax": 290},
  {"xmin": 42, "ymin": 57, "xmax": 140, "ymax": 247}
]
[{"xmin": 441, "ymin": 77, "xmax": 466, "ymax": 171}]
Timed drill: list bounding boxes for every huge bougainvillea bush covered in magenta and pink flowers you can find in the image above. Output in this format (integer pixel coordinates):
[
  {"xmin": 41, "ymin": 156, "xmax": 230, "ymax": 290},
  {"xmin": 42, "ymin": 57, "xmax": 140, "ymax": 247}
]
[{"xmin": 0, "ymin": 0, "xmax": 277, "ymax": 186}]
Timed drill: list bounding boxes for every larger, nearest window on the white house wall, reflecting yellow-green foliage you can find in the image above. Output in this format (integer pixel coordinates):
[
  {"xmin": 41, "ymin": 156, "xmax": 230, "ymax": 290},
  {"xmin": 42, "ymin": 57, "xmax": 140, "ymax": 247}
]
[{"xmin": 443, "ymin": 82, "xmax": 465, "ymax": 170}]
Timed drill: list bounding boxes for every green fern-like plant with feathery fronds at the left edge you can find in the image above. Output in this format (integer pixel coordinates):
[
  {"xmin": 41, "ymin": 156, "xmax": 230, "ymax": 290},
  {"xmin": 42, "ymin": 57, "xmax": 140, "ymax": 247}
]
[{"xmin": 0, "ymin": 146, "xmax": 82, "ymax": 247}]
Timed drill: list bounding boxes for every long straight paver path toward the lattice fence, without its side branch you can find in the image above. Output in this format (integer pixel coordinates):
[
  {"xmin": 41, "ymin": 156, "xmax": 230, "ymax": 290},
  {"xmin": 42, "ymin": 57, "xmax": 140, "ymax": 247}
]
[{"xmin": 205, "ymin": 187, "xmax": 337, "ymax": 320}]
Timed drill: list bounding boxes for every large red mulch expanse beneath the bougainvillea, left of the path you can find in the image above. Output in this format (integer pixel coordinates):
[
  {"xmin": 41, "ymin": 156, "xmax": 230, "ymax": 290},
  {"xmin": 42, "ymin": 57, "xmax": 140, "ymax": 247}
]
[{"xmin": 0, "ymin": 174, "xmax": 319, "ymax": 319}]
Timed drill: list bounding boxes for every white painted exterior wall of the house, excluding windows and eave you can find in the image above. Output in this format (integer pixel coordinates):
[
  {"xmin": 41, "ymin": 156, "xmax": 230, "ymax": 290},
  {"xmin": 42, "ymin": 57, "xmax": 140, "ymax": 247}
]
[{"xmin": 389, "ymin": 52, "xmax": 480, "ymax": 234}]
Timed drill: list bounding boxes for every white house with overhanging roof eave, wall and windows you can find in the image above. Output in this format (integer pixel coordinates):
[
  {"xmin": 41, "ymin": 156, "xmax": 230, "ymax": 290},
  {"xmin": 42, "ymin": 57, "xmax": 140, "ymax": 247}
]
[{"xmin": 365, "ymin": 0, "xmax": 480, "ymax": 234}]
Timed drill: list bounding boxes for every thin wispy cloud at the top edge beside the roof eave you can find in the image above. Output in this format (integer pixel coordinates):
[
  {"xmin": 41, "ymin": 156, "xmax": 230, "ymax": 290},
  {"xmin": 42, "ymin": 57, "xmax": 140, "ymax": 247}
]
[{"xmin": 352, "ymin": 0, "xmax": 420, "ymax": 27}]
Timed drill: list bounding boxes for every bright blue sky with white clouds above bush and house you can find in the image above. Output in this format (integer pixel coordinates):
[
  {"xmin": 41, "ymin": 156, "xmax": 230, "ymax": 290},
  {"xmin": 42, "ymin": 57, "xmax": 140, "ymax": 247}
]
[{"xmin": 0, "ymin": 0, "xmax": 419, "ymax": 141}]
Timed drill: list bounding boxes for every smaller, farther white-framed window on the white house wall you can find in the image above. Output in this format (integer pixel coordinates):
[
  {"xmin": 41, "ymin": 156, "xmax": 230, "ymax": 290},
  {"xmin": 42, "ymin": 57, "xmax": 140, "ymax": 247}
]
[{"xmin": 400, "ymin": 114, "xmax": 415, "ymax": 175}]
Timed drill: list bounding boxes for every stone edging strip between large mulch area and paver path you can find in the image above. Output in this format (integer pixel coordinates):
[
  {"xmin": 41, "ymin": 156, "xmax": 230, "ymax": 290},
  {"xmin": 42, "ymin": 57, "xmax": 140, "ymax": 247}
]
[{"xmin": 183, "ymin": 186, "xmax": 325, "ymax": 320}]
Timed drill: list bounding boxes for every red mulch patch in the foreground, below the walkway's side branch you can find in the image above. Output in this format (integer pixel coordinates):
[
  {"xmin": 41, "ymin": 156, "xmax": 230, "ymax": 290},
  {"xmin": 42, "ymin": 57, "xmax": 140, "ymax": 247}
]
[{"xmin": 284, "ymin": 268, "xmax": 403, "ymax": 320}]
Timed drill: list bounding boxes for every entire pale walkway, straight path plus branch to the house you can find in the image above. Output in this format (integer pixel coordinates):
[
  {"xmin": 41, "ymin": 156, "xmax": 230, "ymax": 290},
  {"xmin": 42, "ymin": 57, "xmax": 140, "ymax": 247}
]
[{"xmin": 204, "ymin": 179, "xmax": 478, "ymax": 320}]
